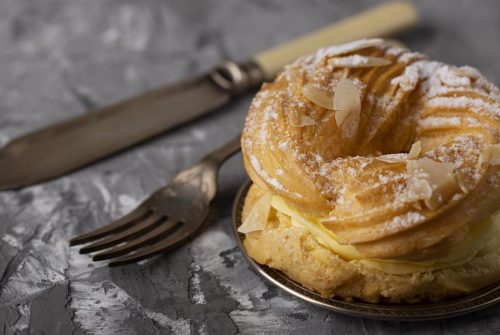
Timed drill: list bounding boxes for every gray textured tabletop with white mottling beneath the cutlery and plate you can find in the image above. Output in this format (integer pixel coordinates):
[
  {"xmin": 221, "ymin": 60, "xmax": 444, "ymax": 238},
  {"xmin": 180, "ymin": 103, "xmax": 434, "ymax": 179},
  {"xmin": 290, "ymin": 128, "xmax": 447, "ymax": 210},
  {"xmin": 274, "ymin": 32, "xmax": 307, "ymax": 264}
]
[{"xmin": 0, "ymin": 0, "xmax": 500, "ymax": 334}]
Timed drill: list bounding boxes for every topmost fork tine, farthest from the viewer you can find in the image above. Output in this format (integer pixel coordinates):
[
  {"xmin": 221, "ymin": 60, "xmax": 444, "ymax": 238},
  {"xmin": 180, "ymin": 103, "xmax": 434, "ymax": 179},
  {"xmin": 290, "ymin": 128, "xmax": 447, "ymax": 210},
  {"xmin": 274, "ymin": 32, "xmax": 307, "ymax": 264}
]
[{"xmin": 69, "ymin": 205, "xmax": 150, "ymax": 246}]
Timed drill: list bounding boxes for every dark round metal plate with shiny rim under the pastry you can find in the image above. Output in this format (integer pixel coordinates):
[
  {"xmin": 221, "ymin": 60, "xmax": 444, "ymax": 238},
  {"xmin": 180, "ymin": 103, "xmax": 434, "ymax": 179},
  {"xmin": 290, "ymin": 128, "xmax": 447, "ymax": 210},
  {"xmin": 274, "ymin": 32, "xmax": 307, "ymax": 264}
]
[{"xmin": 233, "ymin": 181, "xmax": 500, "ymax": 321}]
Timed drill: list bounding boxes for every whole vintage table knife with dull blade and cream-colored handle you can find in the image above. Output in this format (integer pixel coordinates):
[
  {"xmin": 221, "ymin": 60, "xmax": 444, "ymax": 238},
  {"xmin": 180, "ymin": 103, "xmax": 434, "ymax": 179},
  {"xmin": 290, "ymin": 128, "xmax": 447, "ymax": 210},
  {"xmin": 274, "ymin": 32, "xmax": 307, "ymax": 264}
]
[{"xmin": 0, "ymin": 2, "xmax": 417, "ymax": 190}]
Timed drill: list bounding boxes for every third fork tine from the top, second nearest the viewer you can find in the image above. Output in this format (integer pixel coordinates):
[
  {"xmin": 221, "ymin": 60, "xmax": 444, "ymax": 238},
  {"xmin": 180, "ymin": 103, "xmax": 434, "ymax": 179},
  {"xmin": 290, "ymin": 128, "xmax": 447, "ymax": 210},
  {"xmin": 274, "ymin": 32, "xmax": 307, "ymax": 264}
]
[{"xmin": 92, "ymin": 221, "xmax": 179, "ymax": 261}]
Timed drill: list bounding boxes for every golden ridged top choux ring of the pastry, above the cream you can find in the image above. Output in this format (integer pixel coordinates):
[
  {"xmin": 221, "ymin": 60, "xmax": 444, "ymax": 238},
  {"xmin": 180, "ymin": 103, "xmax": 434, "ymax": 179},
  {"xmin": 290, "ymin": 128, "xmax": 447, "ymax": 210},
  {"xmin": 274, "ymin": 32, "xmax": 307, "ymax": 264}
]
[{"xmin": 242, "ymin": 39, "xmax": 500, "ymax": 260}]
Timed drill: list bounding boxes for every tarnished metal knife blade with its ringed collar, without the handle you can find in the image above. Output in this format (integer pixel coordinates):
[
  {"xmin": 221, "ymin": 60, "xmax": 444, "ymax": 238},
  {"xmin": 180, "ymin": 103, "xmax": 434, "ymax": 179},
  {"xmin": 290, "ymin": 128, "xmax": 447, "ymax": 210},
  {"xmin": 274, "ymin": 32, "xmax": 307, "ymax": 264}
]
[{"xmin": 0, "ymin": 63, "xmax": 262, "ymax": 190}]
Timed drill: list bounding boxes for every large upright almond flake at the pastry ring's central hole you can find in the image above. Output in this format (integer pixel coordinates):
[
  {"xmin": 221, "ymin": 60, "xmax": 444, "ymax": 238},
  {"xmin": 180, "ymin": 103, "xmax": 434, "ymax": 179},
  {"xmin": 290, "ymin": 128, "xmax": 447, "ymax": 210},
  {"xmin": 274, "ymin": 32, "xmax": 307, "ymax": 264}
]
[{"xmin": 333, "ymin": 79, "xmax": 361, "ymax": 139}]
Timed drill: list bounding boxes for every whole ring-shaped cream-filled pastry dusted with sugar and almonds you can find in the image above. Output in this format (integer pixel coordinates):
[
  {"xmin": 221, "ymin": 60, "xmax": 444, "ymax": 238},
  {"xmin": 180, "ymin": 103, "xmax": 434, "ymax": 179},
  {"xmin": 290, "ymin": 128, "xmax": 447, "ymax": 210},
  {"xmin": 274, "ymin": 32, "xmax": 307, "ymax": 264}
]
[{"xmin": 239, "ymin": 39, "xmax": 500, "ymax": 303}]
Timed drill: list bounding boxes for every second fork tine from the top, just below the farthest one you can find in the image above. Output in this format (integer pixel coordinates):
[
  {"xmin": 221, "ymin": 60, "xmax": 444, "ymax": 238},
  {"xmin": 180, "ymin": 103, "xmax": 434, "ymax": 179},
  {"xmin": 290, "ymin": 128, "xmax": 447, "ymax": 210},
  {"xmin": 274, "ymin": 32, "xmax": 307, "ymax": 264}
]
[{"xmin": 80, "ymin": 214, "xmax": 165, "ymax": 254}]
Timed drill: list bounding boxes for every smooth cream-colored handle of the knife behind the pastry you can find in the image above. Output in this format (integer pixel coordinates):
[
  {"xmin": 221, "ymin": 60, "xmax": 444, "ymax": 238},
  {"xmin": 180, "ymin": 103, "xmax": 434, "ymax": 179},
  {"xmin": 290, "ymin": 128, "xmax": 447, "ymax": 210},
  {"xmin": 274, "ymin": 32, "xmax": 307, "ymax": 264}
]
[{"xmin": 253, "ymin": 1, "xmax": 418, "ymax": 80}]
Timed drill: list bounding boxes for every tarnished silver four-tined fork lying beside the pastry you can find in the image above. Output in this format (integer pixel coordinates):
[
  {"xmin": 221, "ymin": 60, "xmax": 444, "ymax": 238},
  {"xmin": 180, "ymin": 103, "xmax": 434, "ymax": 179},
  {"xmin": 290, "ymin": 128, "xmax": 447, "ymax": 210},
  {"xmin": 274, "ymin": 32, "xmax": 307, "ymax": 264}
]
[{"xmin": 69, "ymin": 134, "xmax": 241, "ymax": 266}]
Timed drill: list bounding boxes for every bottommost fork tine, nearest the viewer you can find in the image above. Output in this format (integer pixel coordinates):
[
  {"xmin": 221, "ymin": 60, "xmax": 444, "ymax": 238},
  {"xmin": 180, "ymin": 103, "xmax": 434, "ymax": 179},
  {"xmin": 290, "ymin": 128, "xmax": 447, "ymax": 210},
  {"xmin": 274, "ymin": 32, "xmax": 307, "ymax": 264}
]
[{"xmin": 108, "ymin": 224, "xmax": 199, "ymax": 266}]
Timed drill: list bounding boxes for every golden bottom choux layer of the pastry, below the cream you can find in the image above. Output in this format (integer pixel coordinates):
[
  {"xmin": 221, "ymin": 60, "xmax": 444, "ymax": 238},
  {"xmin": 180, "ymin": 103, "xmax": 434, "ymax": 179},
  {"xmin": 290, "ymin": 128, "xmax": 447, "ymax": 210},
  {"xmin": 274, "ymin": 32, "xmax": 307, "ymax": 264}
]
[{"xmin": 243, "ymin": 185, "xmax": 500, "ymax": 303}]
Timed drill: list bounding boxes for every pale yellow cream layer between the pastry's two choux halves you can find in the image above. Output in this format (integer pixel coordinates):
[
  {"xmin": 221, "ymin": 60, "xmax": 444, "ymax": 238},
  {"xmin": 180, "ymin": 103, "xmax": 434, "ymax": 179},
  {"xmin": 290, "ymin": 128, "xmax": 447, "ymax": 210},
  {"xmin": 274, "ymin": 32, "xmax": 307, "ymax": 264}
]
[{"xmin": 271, "ymin": 195, "xmax": 500, "ymax": 274}]
